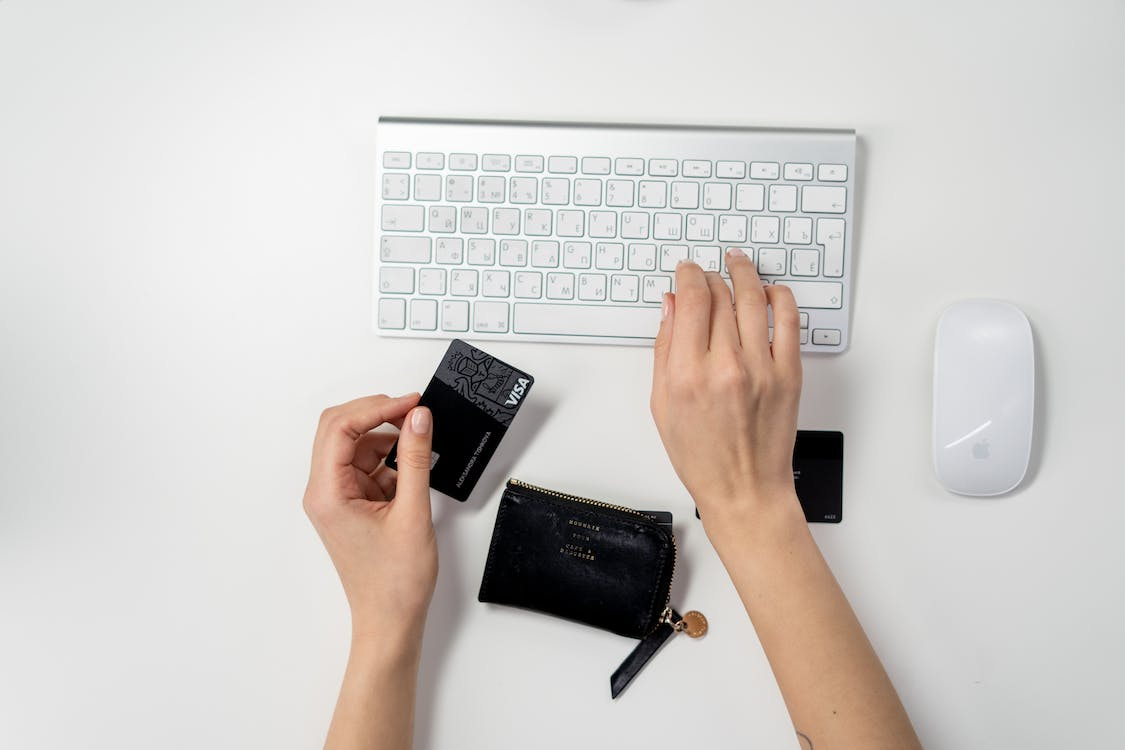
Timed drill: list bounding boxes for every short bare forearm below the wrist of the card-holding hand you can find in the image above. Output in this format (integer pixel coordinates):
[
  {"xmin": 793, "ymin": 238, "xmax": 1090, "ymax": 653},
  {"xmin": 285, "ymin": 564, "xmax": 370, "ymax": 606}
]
[{"xmin": 324, "ymin": 636, "xmax": 422, "ymax": 750}]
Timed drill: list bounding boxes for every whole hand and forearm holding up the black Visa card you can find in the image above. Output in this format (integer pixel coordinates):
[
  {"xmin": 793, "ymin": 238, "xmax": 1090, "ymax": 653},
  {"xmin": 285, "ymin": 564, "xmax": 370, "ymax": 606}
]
[{"xmin": 305, "ymin": 394, "xmax": 438, "ymax": 750}]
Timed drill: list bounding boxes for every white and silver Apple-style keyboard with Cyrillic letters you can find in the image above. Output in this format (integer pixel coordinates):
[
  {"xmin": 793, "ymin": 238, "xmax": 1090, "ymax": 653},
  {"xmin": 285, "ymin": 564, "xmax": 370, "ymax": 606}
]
[{"xmin": 375, "ymin": 118, "xmax": 855, "ymax": 352}]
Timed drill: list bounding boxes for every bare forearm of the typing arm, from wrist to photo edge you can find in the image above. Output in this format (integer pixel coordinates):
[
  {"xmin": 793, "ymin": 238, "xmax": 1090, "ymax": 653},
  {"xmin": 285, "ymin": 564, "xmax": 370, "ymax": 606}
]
[{"xmin": 708, "ymin": 496, "xmax": 919, "ymax": 750}]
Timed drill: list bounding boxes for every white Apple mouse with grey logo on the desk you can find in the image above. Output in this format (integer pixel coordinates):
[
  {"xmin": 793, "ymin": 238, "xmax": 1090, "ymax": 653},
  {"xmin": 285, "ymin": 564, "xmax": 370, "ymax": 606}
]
[{"xmin": 934, "ymin": 299, "xmax": 1035, "ymax": 496}]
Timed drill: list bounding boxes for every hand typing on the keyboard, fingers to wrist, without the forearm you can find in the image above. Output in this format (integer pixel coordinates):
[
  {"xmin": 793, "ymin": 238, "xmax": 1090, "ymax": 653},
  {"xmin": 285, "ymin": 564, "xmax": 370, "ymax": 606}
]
[{"xmin": 651, "ymin": 250, "xmax": 801, "ymax": 541}]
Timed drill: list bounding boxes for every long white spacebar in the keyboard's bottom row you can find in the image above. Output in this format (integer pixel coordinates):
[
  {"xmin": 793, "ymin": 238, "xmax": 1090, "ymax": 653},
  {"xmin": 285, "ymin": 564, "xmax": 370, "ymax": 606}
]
[{"xmin": 512, "ymin": 302, "xmax": 660, "ymax": 338}]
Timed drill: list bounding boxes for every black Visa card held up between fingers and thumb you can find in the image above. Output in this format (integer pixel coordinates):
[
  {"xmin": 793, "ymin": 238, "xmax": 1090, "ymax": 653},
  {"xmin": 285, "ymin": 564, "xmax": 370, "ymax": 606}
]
[{"xmin": 386, "ymin": 338, "xmax": 534, "ymax": 503}]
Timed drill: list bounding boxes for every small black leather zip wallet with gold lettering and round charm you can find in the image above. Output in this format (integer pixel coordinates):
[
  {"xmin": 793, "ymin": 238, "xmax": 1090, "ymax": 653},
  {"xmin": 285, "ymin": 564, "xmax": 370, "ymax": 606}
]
[{"xmin": 478, "ymin": 479, "xmax": 705, "ymax": 697}]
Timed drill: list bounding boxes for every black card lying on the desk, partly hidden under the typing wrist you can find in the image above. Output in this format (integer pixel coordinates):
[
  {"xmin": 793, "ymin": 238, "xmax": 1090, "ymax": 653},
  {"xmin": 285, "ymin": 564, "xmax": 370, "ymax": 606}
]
[{"xmin": 695, "ymin": 430, "xmax": 844, "ymax": 524}]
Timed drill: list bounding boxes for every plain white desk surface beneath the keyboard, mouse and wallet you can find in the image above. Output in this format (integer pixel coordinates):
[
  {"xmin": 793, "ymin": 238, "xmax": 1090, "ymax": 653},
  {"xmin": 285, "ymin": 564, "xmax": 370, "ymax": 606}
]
[{"xmin": 0, "ymin": 0, "xmax": 1125, "ymax": 750}]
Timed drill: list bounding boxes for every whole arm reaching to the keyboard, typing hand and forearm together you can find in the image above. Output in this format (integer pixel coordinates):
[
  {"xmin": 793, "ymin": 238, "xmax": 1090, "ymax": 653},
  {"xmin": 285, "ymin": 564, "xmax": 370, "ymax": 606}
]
[{"xmin": 651, "ymin": 252, "xmax": 920, "ymax": 750}]
